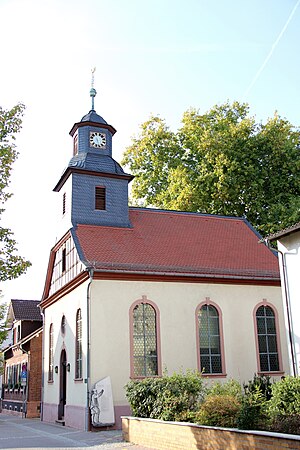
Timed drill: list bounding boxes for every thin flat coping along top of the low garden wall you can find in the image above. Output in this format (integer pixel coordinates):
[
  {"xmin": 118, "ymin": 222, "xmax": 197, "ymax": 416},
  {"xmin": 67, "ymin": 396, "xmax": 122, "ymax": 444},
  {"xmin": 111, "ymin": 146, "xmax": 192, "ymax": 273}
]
[{"xmin": 121, "ymin": 416, "xmax": 300, "ymax": 441}]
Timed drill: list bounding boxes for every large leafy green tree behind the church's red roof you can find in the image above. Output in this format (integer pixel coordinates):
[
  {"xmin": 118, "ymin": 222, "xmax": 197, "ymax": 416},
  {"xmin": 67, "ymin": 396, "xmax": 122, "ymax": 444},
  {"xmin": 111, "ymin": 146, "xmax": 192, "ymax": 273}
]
[{"xmin": 122, "ymin": 102, "xmax": 300, "ymax": 235}]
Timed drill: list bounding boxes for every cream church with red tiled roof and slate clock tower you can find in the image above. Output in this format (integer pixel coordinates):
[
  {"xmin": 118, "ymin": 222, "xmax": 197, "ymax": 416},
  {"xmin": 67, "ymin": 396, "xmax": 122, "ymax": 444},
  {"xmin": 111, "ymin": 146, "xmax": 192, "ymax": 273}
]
[{"xmin": 41, "ymin": 89, "xmax": 288, "ymax": 430}]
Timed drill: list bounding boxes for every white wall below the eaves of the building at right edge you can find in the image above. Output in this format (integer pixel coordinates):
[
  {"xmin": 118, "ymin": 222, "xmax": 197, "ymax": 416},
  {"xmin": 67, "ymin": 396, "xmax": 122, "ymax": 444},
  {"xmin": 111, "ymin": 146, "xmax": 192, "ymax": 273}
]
[{"xmin": 278, "ymin": 231, "xmax": 300, "ymax": 375}]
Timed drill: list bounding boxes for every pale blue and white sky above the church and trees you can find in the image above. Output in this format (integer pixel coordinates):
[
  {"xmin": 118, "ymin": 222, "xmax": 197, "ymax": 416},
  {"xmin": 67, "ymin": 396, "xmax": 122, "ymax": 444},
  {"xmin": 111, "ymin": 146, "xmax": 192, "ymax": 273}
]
[{"xmin": 0, "ymin": 0, "xmax": 300, "ymax": 302}]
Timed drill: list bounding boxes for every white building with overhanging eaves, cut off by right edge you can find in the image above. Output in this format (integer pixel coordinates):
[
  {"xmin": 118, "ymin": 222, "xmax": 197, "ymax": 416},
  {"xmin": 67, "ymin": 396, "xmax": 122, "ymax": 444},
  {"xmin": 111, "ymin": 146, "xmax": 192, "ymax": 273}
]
[{"xmin": 267, "ymin": 222, "xmax": 300, "ymax": 376}]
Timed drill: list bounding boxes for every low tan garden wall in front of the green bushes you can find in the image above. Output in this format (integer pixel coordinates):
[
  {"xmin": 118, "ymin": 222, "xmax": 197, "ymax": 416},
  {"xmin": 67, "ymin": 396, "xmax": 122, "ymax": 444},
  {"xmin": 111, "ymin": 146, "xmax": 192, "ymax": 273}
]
[{"xmin": 122, "ymin": 417, "xmax": 300, "ymax": 450}]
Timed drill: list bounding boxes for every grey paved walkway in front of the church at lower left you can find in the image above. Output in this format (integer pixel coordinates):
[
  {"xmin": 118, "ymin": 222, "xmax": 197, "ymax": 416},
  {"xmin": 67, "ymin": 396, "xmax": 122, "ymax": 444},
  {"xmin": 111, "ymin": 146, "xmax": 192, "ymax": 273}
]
[{"xmin": 0, "ymin": 413, "xmax": 156, "ymax": 450}]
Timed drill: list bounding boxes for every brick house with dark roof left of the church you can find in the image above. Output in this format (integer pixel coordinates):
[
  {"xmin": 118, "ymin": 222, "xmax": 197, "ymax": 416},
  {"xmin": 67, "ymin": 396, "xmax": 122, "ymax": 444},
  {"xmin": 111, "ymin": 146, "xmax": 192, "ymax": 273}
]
[{"xmin": 2, "ymin": 299, "xmax": 43, "ymax": 417}]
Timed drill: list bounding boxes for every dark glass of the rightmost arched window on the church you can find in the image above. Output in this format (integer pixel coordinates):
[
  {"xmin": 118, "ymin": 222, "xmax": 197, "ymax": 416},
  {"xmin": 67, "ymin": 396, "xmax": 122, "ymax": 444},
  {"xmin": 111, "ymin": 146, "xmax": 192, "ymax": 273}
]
[{"xmin": 256, "ymin": 305, "xmax": 279, "ymax": 372}]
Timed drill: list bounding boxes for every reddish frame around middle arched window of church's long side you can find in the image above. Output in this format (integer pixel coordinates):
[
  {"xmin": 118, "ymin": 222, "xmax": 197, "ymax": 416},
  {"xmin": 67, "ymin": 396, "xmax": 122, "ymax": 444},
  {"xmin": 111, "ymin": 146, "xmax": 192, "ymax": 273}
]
[{"xmin": 195, "ymin": 297, "xmax": 227, "ymax": 378}]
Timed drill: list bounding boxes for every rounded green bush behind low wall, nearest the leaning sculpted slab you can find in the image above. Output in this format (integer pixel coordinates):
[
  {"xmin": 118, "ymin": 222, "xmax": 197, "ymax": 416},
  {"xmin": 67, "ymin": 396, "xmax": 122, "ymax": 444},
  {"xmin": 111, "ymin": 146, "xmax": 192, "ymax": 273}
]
[{"xmin": 125, "ymin": 371, "xmax": 204, "ymax": 420}]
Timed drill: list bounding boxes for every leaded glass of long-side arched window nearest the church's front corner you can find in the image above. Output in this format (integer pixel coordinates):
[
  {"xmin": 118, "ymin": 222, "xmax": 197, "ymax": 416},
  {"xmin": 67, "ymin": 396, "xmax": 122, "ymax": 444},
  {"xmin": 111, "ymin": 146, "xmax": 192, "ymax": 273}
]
[{"xmin": 133, "ymin": 303, "xmax": 158, "ymax": 377}]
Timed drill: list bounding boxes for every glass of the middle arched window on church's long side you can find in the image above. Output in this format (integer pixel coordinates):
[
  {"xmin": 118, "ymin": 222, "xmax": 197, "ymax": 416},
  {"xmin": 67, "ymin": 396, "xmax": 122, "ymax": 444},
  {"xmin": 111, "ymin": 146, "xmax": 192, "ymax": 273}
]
[{"xmin": 198, "ymin": 305, "xmax": 222, "ymax": 373}]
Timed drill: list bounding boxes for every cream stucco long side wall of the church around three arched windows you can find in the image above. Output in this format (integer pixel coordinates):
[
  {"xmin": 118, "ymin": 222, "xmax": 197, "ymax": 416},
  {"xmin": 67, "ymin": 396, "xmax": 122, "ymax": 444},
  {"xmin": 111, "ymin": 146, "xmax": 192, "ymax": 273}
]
[{"xmin": 91, "ymin": 281, "xmax": 288, "ymax": 405}]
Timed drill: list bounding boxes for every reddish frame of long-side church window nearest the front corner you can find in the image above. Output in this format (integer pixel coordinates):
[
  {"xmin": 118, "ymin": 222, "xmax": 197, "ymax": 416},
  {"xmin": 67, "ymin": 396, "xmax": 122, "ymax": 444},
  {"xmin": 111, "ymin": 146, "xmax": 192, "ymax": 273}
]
[{"xmin": 129, "ymin": 295, "xmax": 162, "ymax": 379}]
